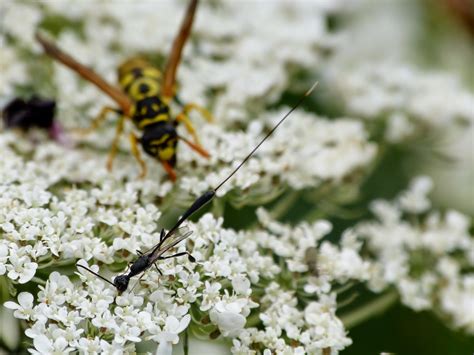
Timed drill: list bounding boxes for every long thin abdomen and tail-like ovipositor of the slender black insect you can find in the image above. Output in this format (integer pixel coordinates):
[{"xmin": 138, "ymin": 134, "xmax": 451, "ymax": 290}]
[{"xmin": 159, "ymin": 81, "xmax": 318, "ymax": 242}]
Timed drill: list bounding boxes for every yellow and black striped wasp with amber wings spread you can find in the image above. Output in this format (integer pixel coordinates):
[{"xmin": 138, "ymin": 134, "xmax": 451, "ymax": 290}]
[{"xmin": 36, "ymin": 0, "xmax": 212, "ymax": 181}]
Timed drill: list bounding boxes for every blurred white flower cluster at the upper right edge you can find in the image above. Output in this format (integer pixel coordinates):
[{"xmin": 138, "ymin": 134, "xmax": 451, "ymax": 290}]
[{"xmin": 331, "ymin": 62, "xmax": 474, "ymax": 142}]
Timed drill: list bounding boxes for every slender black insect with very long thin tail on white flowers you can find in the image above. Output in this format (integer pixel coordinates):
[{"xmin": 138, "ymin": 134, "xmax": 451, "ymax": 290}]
[{"xmin": 77, "ymin": 82, "xmax": 317, "ymax": 292}]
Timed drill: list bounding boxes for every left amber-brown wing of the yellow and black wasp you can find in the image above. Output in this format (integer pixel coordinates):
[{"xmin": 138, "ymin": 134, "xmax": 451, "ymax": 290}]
[{"xmin": 36, "ymin": 32, "xmax": 132, "ymax": 114}]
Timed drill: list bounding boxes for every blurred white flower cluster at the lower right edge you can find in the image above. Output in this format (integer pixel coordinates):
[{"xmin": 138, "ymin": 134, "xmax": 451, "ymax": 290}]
[{"xmin": 355, "ymin": 177, "xmax": 474, "ymax": 333}]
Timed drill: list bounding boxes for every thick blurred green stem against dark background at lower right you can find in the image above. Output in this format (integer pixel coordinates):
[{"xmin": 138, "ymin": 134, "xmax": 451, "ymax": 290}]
[{"xmin": 339, "ymin": 290, "xmax": 398, "ymax": 329}]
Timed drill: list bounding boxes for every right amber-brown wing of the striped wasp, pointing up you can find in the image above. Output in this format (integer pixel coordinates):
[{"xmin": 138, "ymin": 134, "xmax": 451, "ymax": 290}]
[{"xmin": 162, "ymin": 0, "xmax": 198, "ymax": 98}]
